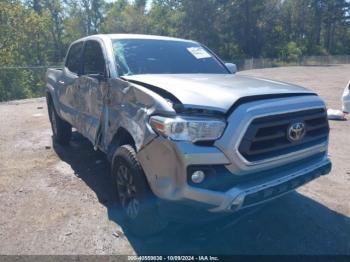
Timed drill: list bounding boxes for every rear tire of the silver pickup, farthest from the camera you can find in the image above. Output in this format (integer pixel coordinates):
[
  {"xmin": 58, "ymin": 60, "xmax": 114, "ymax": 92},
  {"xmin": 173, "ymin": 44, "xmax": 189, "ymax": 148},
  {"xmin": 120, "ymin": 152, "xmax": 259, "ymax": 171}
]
[{"xmin": 48, "ymin": 101, "xmax": 72, "ymax": 145}]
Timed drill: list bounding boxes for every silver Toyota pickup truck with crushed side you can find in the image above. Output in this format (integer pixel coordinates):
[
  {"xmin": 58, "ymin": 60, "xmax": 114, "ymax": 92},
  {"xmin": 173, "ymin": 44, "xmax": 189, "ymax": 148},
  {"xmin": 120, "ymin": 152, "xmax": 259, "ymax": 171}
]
[{"xmin": 47, "ymin": 34, "xmax": 331, "ymax": 234}]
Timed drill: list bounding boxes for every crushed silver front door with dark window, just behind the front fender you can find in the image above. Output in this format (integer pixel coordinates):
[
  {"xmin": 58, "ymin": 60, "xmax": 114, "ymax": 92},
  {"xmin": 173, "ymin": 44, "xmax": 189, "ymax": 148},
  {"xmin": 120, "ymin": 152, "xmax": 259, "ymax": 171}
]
[{"xmin": 79, "ymin": 40, "xmax": 107, "ymax": 145}]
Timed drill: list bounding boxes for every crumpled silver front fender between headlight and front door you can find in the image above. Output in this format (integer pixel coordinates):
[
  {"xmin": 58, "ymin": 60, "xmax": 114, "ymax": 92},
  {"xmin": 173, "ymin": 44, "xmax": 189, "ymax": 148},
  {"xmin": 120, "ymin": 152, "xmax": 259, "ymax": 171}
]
[{"xmin": 101, "ymin": 79, "xmax": 176, "ymax": 151}]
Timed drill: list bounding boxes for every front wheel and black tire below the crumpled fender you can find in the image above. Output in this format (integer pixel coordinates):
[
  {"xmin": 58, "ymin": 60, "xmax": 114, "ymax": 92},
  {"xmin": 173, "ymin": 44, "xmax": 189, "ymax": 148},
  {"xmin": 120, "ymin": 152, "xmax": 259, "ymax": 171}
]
[{"xmin": 111, "ymin": 145, "xmax": 167, "ymax": 236}]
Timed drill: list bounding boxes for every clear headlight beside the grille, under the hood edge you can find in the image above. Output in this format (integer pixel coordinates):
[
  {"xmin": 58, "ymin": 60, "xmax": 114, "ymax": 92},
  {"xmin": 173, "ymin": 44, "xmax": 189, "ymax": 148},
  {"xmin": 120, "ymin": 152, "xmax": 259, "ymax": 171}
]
[{"xmin": 150, "ymin": 116, "xmax": 226, "ymax": 142}]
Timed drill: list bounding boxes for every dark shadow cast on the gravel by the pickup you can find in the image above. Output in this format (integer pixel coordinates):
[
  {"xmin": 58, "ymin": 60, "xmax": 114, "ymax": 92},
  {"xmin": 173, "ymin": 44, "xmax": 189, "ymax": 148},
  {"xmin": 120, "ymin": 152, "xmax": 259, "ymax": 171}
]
[{"xmin": 54, "ymin": 132, "xmax": 350, "ymax": 255}]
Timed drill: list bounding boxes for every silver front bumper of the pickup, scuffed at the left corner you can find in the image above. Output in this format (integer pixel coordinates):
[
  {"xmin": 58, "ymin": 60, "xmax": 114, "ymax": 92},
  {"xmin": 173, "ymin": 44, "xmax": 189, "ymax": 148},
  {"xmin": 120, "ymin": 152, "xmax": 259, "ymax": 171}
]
[{"xmin": 138, "ymin": 137, "xmax": 331, "ymax": 212}]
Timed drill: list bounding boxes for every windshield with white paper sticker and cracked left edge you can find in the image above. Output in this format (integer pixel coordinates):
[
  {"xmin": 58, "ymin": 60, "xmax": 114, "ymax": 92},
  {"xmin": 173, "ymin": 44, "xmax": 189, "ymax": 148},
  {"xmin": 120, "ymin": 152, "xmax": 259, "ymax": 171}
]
[{"xmin": 113, "ymin": 39, "xmax": 229, "ymax": 76}]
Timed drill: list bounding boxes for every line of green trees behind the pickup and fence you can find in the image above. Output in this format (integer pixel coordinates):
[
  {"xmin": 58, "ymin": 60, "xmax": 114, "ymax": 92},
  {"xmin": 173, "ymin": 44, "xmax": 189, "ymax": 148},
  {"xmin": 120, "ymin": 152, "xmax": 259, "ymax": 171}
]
[{"xmin": 0, "ymin": 0, "xmax": 350, "ymax": 101}]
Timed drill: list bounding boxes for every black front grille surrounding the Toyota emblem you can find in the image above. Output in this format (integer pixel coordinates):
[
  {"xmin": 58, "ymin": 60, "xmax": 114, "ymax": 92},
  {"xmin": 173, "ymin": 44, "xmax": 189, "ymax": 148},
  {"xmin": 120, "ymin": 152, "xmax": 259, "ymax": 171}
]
[{"xmin": 239, "ymin": 108, "xmax": 329, "ymax": 162}]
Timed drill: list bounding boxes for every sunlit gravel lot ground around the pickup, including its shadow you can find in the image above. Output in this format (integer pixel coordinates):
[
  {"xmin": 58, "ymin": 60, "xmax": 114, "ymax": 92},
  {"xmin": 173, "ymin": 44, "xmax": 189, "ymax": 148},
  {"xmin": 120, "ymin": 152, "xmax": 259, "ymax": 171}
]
[{"xmin": 0, "ymin": 66, "xmax": 350, "ymax": 255}]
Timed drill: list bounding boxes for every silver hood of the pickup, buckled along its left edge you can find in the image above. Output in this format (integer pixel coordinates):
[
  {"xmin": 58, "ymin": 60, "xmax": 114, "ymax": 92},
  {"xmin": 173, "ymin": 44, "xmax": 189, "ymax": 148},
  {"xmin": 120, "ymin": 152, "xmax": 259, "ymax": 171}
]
[{"xmin": 123, "ymin": 74, "xmax": 313, "ymax": 112}]
